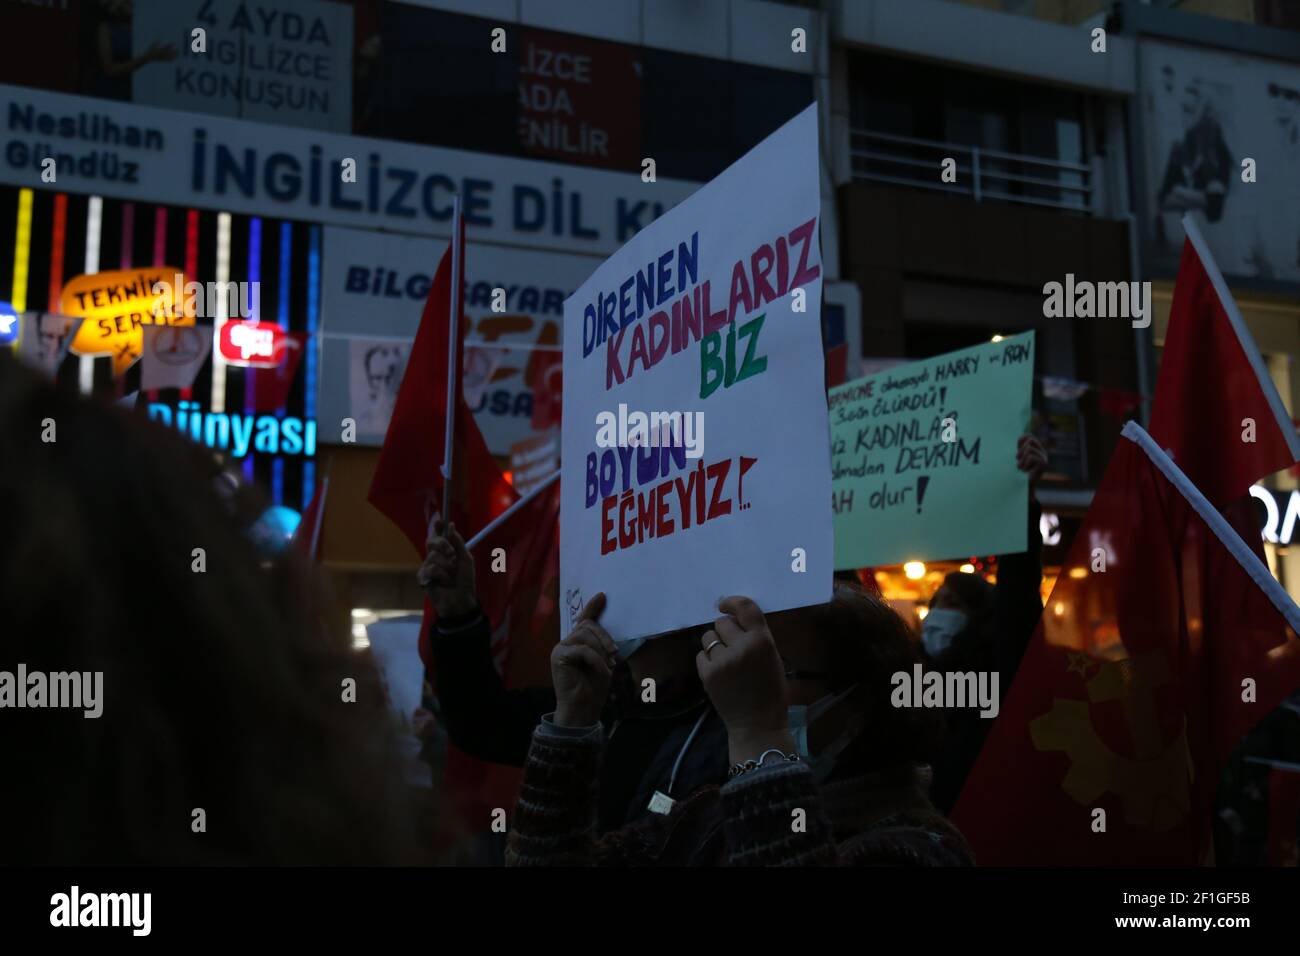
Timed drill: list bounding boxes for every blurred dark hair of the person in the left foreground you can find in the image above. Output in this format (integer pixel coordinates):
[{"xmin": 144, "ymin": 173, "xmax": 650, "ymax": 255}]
[{"xmin": 0, "ymin": 352, "xmax": 428, "ymax": 864}]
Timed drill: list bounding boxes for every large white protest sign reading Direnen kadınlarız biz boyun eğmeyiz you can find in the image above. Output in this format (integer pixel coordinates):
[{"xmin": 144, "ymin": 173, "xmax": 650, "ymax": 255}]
[{"xmin": 560, "ymin": 107, "xmax": 833, "ymax": 640}]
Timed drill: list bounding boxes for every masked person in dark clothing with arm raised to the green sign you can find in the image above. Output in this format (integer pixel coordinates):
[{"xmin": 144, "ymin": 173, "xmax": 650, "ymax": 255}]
[{"xmin": 920, "ymin": 434, "xmax": 1048, "ymax": 813}]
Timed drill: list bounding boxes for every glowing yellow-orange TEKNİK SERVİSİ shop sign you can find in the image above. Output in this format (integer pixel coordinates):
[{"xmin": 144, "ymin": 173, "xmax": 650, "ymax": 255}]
[{"xmin": 60, "ymin": 265, "xmax": 194, "ymax": 375}]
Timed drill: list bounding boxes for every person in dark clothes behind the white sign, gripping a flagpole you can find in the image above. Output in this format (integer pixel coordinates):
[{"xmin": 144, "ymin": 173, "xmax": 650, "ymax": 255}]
[{"xmin": 419, "ymin": 520, "xmax": 728, "ymax": 832}]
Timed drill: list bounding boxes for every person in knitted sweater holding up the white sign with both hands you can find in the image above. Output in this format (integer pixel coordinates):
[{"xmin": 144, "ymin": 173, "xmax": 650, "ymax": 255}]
[{"xmin": 506, "ymin": 585, "xmax": 972, "ymax": 866}]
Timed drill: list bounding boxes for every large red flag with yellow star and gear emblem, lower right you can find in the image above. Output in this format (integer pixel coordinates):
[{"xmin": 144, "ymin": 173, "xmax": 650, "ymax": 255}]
[{"xmin": 953, "ymin": 421, "xmax": 1300, "ymax": 865}]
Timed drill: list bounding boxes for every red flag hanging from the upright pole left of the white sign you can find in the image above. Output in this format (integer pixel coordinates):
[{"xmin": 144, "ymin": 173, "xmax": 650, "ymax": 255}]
[{"xmin": 368, "ymin": 210, "xmax": 519, "ymax": 558}]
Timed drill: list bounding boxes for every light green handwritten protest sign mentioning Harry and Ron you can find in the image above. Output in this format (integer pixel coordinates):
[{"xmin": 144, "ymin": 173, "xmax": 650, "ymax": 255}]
[{"xmin": 829, "ymin": 332, "xmax": 1034, "ymax": 570}]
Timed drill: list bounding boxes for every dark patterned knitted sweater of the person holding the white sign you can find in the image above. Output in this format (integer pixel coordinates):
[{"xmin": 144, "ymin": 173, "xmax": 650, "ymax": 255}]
[{"xmin": 506, "ymin": 727, "xmax": 974, "ymax": 866}]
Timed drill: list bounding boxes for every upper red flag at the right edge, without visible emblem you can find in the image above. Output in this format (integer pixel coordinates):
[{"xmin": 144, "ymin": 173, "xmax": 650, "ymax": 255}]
[{"xmin": 1151, "ymin": 216, "xmax": 1300, "ymax": 509}]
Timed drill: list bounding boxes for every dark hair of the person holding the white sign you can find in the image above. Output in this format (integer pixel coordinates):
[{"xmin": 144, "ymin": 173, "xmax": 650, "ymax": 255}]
[{"xmin": 802, "ymin": 584, "xmax": 944, "ymax": 777}]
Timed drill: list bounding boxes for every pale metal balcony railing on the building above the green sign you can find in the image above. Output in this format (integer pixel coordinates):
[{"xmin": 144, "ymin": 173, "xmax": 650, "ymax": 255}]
[{"xmin": 849, "ymin": 127, "xmax": 1095, "ymax": 215}]
